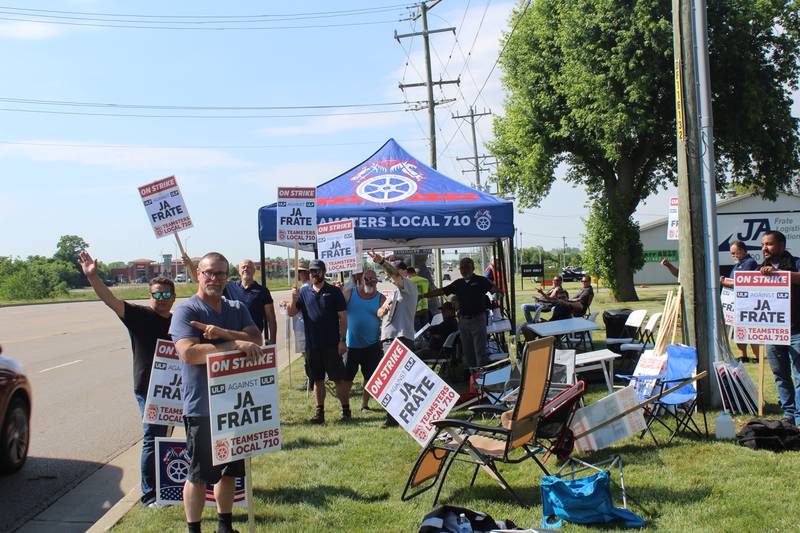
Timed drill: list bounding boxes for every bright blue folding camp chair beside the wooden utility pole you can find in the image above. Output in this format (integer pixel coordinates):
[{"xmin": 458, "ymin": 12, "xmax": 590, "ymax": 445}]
[{"xmin": 620, "ymin": 344, "xmax": 708, "ymax": 446}]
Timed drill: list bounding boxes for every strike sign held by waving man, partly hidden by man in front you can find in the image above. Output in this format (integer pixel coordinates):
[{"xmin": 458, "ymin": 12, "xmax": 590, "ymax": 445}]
[{"xmin": 142, "ymin": 339, "xmax": 183, "ymax": 426}]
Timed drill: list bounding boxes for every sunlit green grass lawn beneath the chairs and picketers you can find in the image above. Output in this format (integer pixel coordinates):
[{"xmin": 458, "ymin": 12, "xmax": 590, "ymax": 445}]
[{"xmin": 114, "ymin": 282, "xmax": 800, "ymax": 533}]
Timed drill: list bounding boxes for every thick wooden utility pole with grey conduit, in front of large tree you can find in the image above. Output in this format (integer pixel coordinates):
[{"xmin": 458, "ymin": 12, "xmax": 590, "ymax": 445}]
[{"xmin": 672, "ymin": 0, "xmax": 724, "ymax": 407}]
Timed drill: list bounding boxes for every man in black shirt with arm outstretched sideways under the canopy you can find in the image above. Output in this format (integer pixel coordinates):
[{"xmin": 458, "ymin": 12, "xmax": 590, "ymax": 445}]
[{"xmin": 422, "ymin": 257, "xmax": 497, "ymax": 367}]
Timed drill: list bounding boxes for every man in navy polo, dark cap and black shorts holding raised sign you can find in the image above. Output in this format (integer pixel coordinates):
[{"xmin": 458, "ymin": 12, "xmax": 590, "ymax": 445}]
[{"xmin": 289, "ymin": 259, "xmax": 353, "ymax": 424}]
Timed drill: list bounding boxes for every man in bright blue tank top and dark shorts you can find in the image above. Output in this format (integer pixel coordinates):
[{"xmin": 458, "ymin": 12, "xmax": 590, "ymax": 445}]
[{"xmin": 344, "ymin": 269, "xmax": 386, "ymax": 411}]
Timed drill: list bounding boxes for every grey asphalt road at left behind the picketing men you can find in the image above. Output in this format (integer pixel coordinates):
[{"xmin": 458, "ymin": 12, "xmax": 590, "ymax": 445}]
[{"xmin": 0, "ymin": 291, "xmax": 288, "ymax": 531}]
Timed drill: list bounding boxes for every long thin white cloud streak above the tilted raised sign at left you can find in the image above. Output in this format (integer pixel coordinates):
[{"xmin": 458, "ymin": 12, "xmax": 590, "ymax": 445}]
[{"xmin": 0, "ymin": 140, "xmax": 250, "ymax": 170}]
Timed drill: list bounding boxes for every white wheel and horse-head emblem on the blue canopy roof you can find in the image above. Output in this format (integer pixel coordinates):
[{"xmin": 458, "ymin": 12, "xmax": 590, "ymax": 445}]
[{"xmin": 350, "ymin": 159, "xmax": 425, "ymax": 204}]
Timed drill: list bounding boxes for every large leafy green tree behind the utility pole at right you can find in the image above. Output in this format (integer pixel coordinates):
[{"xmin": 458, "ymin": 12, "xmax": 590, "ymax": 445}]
[{"xmin": 490, "ymin": 0, "xmax": 800, "ymax": 300}]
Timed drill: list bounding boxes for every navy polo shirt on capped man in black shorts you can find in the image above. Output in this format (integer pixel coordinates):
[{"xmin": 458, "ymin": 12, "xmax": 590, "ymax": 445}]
[{"xmin": 294, "ymin": 283, "xmax": 347, "ymax": 350}]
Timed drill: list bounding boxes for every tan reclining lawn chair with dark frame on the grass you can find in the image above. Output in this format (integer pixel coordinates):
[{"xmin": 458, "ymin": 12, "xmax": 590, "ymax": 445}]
[{"xmin": 402, "ymin": 337, "xmax": 583, "ymax": 505}]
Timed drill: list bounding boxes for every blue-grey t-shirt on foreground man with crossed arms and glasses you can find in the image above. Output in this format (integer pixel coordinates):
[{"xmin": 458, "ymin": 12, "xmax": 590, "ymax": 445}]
[{"xmin": 169, "ymin": 294, "xmax": 255, "ymax": 416}]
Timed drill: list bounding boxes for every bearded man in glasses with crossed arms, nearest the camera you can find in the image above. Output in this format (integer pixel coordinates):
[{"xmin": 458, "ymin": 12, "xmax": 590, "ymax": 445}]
[{"xmin": 169, "ymin": 252, "xmax": 261, "ymax": 533}]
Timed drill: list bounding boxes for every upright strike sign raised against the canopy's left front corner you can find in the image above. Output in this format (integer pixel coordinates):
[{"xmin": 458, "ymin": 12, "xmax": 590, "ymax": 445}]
[{"xmin": 276, "ymin": 187, "xmax": 317, "ymax": 243}]
